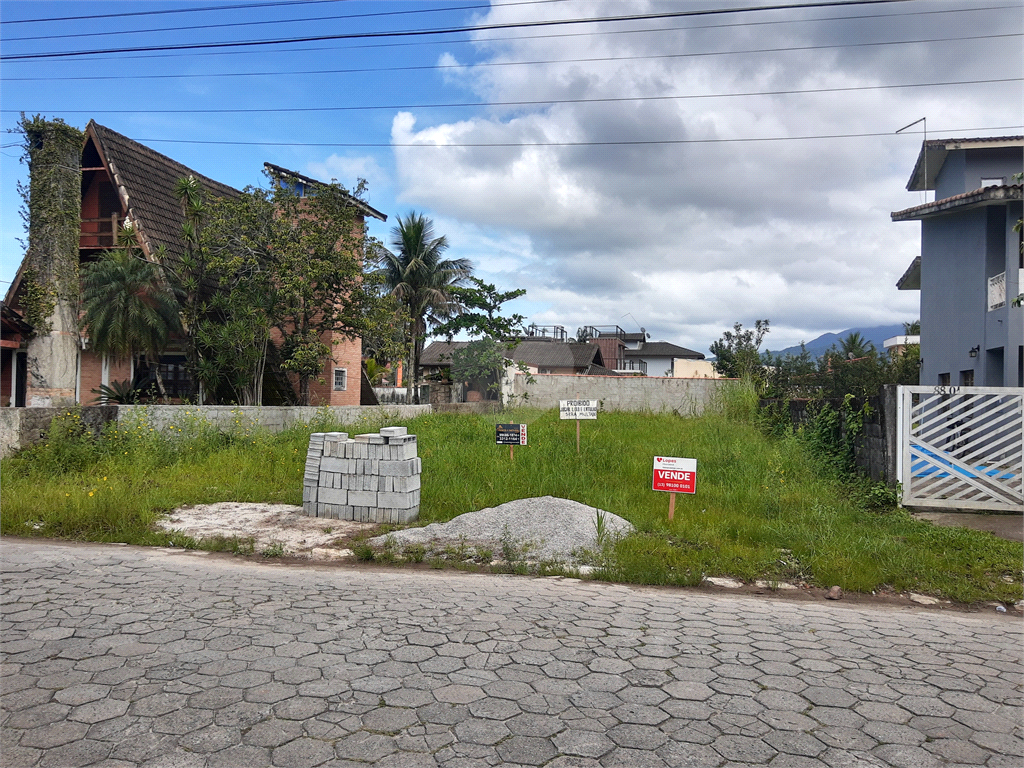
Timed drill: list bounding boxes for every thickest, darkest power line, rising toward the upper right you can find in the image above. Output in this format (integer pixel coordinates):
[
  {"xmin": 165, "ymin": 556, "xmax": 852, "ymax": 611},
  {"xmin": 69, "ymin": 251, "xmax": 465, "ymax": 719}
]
[{"xmin": 0, "ymin": 0, "xmax": 913, "ymax": 61}]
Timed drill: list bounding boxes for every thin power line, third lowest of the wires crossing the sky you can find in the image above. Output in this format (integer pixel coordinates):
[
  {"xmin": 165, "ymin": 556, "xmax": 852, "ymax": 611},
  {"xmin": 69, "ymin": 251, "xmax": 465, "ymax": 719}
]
[{"xmin": 4, "ymin": 32, "xmax": 1024, "ymax": 82}]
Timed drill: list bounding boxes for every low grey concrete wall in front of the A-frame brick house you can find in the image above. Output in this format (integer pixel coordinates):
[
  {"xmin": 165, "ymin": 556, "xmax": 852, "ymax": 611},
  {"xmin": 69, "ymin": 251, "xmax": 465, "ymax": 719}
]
[{"xmin": 0, "ymin": 406, "xmax": 430, "ymax": 457}]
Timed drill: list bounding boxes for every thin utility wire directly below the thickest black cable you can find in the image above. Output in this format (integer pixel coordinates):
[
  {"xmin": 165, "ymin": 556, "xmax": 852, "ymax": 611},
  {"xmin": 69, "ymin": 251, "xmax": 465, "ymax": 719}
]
[{"xmin": 5, "ymin": 5, "xmax": 1007, "ymax": 65}]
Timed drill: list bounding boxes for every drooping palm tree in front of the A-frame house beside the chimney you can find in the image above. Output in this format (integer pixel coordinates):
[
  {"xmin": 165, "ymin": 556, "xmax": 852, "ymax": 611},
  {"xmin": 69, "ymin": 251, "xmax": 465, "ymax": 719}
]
[{"xmin": 81, "ymin": 228, "xmax": 181, "ymax": 402}]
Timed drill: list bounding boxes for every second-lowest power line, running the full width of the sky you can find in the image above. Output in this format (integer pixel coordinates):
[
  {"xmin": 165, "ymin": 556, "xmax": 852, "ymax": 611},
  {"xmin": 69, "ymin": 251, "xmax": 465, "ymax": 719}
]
[{"xmin": 8, "ymin": 78, "xmax": 1024, "ymax": 115}]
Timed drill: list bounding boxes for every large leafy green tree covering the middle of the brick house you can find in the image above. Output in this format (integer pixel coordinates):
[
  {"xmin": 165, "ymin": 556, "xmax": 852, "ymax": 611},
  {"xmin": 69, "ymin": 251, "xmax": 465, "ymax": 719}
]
[{"xmin": 177, "ymin": 180, "xmax": 385, "ymax": 404}]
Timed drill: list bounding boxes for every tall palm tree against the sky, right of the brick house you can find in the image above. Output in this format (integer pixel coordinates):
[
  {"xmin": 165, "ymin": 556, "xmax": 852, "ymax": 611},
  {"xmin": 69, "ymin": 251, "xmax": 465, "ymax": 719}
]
[{"xmin": 381, "ymin": 211, "xmax": 472, "ymax": 404}]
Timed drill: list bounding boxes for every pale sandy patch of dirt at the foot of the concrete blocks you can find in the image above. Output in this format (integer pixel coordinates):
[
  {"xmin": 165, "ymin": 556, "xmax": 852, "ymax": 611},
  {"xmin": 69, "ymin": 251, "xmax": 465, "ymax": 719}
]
[{"xmin": 158, "ymin": 502, "xmax": 375, "ymax": 560}]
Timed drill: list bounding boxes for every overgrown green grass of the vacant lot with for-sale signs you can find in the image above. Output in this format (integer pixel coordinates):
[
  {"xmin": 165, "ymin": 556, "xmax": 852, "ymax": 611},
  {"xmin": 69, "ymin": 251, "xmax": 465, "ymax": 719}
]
[{"xmin": 0, "ymin": 396, "xmax": 1024, "ymax": 602}]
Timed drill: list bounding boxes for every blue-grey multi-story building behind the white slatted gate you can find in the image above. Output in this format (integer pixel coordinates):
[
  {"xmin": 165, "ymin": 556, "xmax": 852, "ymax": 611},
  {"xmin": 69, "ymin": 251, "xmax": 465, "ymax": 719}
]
[{"xmin": 892, "ymin": 136, "xmax": 1024, "ymax": 387}]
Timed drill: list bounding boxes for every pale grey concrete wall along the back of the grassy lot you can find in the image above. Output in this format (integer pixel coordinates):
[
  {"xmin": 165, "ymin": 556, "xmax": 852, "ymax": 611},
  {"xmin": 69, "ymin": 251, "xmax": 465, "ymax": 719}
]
[{"xmin": 512, "ymin": 374, "xmax": 736, "ymax": 416}]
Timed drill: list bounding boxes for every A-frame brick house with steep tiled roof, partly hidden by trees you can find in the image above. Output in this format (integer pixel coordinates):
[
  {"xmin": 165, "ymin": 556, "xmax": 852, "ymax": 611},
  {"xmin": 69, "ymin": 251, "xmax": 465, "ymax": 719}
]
[{"xmin": 0, "ymin": 121, "xmax": 387, "ymax": 406}]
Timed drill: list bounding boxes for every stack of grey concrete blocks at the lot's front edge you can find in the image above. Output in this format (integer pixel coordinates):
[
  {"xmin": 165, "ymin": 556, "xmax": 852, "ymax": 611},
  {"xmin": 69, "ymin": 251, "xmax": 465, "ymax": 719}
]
[{"xmin": 302, "ymin": 427, "xmax": 423, "ymax": 523}]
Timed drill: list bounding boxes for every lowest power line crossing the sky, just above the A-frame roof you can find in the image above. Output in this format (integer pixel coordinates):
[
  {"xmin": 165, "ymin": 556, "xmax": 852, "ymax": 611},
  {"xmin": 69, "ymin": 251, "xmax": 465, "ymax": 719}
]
[{"xmin": 128, "ymin": 125, "xmax": 1024, "ymax": 150}]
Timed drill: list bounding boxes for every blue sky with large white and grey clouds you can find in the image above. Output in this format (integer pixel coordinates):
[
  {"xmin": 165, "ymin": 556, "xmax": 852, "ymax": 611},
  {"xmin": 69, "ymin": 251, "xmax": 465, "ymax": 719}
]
[{"xmin": 0, "ymin": 0, "xmax": 1024, "ymax": 352}]
